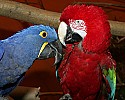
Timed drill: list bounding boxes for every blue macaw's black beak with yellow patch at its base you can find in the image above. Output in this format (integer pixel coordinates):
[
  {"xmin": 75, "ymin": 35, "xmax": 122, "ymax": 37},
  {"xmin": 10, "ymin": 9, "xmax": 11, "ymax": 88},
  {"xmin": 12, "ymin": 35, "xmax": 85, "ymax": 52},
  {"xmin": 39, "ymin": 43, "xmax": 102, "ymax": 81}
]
[{"xmin": 37, "ymin": 40, "xmax": 62, "ymax": 64}]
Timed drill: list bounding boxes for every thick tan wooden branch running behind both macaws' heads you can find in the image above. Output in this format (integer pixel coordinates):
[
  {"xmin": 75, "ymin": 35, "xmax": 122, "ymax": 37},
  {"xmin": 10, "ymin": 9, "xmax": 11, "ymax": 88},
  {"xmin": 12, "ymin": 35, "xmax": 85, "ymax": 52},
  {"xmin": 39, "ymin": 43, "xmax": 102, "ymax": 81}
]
[{"xmin": 0, "ymin": 0, "xmax": 125, "ymax": 36}]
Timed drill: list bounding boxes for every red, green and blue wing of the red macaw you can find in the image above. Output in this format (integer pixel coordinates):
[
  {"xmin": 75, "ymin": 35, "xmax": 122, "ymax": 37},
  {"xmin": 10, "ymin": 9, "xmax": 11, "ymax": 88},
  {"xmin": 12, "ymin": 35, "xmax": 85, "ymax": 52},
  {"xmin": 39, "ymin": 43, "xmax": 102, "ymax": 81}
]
[{"xmin": 101, "ymin": 52, "xmax": 116, "ymax": 100}]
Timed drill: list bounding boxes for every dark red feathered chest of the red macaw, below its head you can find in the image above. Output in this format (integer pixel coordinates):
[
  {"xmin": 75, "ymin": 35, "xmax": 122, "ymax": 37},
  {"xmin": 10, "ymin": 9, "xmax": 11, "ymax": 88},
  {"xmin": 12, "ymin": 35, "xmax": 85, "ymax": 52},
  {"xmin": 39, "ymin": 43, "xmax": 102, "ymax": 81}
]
[{"xmin": 59, "ymin": 46, "xmax": 102, "ymax": 100}]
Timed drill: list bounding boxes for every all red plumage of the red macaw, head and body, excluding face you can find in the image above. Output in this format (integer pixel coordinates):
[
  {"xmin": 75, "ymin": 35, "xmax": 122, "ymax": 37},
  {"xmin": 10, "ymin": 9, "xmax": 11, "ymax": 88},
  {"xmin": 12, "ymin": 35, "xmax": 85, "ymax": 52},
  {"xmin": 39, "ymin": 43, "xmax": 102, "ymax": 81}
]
[{"xmin": 58, "ymin": 5, "xmax": 115, "ymax": 100}]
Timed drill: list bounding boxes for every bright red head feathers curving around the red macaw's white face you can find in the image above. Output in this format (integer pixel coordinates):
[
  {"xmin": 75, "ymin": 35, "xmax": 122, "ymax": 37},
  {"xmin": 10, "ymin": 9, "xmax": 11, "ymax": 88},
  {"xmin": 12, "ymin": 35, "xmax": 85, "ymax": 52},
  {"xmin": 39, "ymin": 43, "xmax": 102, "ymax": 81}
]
[{"xmin": 60, "ymin": 5, "xmax": 111, "ymax": 53}]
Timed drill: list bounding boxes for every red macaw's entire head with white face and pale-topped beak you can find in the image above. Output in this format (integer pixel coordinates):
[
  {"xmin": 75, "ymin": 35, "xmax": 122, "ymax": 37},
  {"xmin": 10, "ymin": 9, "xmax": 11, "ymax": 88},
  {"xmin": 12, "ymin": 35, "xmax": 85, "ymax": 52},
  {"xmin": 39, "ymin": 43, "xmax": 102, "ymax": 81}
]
[{"xmin": 58, "ymin": 5, "xmax": 111, "ymax": 53}]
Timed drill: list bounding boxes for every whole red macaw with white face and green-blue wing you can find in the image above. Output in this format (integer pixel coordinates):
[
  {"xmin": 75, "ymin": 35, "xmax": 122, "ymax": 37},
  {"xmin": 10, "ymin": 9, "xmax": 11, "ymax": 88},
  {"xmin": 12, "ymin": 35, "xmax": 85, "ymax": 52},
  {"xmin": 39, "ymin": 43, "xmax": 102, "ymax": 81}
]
[{"xmin": 57, "ymin": 5, "xmax": 116, "ymax": 100}]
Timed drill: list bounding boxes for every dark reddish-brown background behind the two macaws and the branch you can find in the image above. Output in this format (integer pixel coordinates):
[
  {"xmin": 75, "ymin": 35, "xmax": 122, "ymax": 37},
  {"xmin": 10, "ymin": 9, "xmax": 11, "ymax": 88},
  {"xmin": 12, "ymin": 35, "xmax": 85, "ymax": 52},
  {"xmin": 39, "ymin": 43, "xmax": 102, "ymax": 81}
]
[{"xmin": 0, "ymin": 0, "xmax": 125, "ymax": 100}]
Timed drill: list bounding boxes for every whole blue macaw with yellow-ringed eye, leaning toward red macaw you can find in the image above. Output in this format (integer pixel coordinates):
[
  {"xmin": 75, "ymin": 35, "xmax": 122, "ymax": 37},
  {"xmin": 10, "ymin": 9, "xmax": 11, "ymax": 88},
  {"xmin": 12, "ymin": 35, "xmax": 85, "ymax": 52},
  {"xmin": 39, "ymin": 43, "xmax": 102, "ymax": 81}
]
[{"xmin": 0, "ymin": 25, "xmax": 62, "ymax": 100}]
